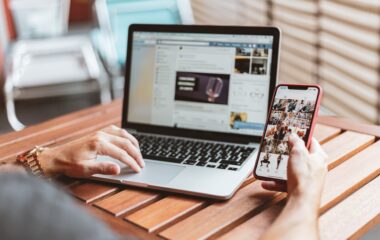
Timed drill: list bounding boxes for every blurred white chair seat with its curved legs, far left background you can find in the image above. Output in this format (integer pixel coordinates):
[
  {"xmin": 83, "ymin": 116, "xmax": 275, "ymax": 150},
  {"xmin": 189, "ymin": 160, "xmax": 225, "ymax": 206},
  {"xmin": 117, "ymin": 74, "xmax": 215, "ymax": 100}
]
[{"xmin": 4, "ymin": 36, "xmax": 111, "ymax": 130}]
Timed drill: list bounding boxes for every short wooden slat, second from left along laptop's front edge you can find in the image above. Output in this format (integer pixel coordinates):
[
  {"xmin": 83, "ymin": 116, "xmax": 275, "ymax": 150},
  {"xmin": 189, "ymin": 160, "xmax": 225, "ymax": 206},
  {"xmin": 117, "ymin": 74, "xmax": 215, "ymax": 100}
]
[{"xmin": 94, "ymin": 189, "xmax": 159, "ymax": 216}]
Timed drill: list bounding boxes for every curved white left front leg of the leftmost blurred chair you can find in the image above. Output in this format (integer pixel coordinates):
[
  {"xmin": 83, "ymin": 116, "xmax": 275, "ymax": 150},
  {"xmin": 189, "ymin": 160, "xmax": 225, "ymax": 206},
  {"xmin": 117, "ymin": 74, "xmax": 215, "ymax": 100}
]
[{"xmin": 4, "ymin": 81, "xmax": 25, "ymax": 131}]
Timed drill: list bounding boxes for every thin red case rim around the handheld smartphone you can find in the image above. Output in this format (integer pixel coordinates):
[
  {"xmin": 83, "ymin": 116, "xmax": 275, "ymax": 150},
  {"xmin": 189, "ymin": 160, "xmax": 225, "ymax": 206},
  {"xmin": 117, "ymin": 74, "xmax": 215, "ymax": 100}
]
[{"xmin": 253, "ymin": 84, "xmax": 323, "ymax": 182}]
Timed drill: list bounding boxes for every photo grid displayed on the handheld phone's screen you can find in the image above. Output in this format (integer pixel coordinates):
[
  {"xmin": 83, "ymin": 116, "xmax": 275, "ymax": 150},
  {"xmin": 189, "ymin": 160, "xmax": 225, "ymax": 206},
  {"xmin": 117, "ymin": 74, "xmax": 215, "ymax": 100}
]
[{"xmin": 256, "ymin": 98, "xmax": 315, "ymax": 179}]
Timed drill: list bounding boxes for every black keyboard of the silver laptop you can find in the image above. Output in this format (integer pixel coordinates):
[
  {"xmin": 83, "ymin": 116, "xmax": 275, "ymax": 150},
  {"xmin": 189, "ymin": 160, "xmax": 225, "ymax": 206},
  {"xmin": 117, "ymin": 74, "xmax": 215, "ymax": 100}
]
[{"xmin": 133, "ymin": 134, "xmax": 255, "ymax": 171}]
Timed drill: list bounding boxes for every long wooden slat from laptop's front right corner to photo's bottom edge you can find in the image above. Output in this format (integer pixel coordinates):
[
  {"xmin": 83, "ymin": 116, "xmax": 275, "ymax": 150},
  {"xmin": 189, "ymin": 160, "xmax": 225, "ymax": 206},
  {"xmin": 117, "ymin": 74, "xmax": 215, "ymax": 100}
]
[{"xmin": 160, "ymin": 181, "xmax": 278, "ymax": 239}]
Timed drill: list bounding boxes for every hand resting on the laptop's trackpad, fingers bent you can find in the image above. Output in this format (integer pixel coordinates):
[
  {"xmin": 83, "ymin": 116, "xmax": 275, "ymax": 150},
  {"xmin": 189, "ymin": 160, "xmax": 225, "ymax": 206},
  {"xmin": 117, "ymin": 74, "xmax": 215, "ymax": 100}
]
[{"xmin": 39, "ymin": 126, "xmax": 145, "ymax": 177}]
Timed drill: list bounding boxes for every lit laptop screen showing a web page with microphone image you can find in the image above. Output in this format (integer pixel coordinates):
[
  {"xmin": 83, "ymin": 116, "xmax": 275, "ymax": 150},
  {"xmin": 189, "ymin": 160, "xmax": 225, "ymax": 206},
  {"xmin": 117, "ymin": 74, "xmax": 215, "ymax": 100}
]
[{"xmin": 127, "ymin": 31, "xmax": 273, "ymax": 136}]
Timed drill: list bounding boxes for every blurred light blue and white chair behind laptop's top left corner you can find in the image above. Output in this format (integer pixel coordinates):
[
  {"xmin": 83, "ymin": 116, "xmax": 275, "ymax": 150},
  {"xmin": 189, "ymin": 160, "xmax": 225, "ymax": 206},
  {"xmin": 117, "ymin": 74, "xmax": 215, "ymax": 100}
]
[{"xmin": 92, "ymin": 0, "xmax": 194, "ymax": 97}]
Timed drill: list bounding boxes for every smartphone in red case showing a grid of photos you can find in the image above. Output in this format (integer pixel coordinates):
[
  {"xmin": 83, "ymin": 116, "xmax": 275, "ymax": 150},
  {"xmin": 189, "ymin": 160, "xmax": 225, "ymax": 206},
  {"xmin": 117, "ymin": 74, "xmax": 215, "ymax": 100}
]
[{"xmin": 253, "ymin": 84, "xmax": 322, "ymax": 181}]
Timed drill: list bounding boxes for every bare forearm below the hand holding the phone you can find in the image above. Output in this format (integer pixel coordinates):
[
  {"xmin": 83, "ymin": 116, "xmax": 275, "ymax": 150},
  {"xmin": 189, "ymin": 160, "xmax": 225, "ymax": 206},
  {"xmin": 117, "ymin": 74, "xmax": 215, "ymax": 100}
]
[{"xmin": 261, "ymin": 194, "xmax": 319, "ymax": 240}]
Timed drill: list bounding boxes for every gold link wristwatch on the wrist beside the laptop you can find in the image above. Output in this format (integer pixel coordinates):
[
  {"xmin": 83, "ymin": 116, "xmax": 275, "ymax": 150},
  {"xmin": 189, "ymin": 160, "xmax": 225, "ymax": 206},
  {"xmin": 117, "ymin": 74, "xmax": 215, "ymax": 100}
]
[{"xmin": 16, "ymin": 146, "xmax": 46, "ymax": 177}]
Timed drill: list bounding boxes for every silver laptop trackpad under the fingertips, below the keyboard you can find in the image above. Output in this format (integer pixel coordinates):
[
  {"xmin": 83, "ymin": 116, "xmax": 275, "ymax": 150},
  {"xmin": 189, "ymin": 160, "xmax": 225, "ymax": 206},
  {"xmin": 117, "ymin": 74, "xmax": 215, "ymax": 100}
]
[{"xmin": 120, "ymin": 161, "xmax": 186, "ymax": 185}]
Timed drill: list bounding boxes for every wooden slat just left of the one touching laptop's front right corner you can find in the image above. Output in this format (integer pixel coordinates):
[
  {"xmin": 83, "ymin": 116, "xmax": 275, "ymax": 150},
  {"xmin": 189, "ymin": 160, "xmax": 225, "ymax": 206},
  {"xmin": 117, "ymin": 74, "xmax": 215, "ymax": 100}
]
[{"xmin": 125, "ymin": 196, "xmax": 206, "ymax": 232}]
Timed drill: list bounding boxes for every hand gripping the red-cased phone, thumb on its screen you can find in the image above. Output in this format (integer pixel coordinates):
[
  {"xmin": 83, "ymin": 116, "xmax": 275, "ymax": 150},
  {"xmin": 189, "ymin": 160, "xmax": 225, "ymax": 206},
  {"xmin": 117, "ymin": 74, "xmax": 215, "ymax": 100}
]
[{"xmin": 262, "ymin": 134, "xmax": 327, "ymax": 207}]
